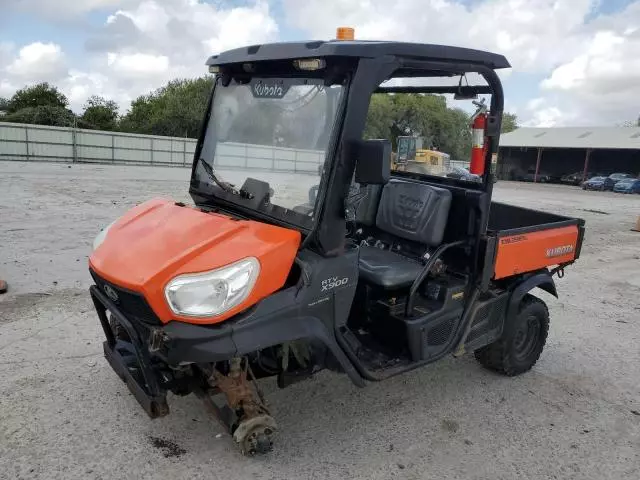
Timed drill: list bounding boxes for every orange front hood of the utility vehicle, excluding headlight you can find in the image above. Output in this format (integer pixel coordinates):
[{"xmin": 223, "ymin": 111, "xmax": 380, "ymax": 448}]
[{"xmin": 89, "ymin": 199, "xmax": 301, "ymax": 324}]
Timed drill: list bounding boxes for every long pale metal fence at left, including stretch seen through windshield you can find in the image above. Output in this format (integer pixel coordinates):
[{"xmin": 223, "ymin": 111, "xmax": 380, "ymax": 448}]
[{"xmin": 0, "ymin": 122, "xmax": 324, "ymax": 173}]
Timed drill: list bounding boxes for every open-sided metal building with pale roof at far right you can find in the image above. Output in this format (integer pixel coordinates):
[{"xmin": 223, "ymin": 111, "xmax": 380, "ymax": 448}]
[{"xmin": 497, "ymin": 127, "xmax": 640, "ymax": 181}]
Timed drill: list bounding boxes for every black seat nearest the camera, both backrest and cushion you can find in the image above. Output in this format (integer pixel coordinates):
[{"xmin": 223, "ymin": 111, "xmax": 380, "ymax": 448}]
[{"xmin": 360, "ymin": 181, "xmax": 451, "ymax": 289}]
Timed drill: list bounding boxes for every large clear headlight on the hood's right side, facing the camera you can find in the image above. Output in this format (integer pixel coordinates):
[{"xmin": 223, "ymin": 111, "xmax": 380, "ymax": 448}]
[{"xmin": 164, "ymin": 257, "xmax": 260, "ymax": 317}]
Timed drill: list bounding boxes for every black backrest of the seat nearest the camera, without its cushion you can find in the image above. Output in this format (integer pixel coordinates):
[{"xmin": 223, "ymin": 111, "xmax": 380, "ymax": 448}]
[{"xmin": 376, "ymin": 181, "xmax": 451, "ymax": 247}]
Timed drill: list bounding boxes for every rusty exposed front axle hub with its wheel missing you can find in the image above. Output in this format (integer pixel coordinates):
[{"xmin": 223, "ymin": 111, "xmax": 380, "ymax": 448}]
[{"xmin": 203, "ymin": 357, "xmax": 276, "ymax": 455}]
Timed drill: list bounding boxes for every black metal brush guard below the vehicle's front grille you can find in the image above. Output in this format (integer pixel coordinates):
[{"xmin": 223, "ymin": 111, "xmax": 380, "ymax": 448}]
[{"xmin": 89, "ymin": 285, "xmax": 169, "ymax": 418}]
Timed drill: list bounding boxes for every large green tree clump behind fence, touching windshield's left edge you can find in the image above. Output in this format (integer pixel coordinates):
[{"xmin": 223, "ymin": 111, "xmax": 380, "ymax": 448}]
[{"xmin": 120, "ymin": 77, "xmax": 213, "ymax": 137}]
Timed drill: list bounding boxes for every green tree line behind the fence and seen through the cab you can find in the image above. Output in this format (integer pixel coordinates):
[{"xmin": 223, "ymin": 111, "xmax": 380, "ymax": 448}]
[{"xmin": 0, "ymin": 76, "xmax": 517, "ymax": 158}]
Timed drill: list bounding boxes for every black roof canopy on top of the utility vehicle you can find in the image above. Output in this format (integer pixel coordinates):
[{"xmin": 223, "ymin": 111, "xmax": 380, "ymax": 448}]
[{"xmin": 207, "ymin": 40, "xmax": 511, "ymax": 69}]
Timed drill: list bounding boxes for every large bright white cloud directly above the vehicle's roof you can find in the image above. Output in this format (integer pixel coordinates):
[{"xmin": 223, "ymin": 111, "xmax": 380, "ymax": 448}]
[{"xmin": 283, "ymin": 0, "xmax": 593, "ymax": 72}]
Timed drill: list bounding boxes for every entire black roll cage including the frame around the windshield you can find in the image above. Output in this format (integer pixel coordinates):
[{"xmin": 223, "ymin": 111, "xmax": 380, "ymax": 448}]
[{"xmin": 190, "ymin": 50, "xmax": 504, "ymax": 256}]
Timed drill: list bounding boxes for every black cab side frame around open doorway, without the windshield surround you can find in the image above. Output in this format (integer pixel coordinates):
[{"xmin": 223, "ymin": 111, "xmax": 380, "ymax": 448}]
[{"xmin": 306, "ymin": 56, "xmax": 504, "ymax": 255}]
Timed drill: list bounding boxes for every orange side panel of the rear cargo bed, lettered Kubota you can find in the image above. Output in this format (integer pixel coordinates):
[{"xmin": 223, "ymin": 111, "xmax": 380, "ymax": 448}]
[{"xmin": 493, "ymin": 226, "xmax": 578, "ymax": 280}]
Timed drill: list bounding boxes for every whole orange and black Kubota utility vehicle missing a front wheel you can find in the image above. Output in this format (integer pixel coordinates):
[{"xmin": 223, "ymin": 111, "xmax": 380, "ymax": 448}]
[{"xmin": 89, "ymin": 30, "xmax": 584, "ymax": 454}]
